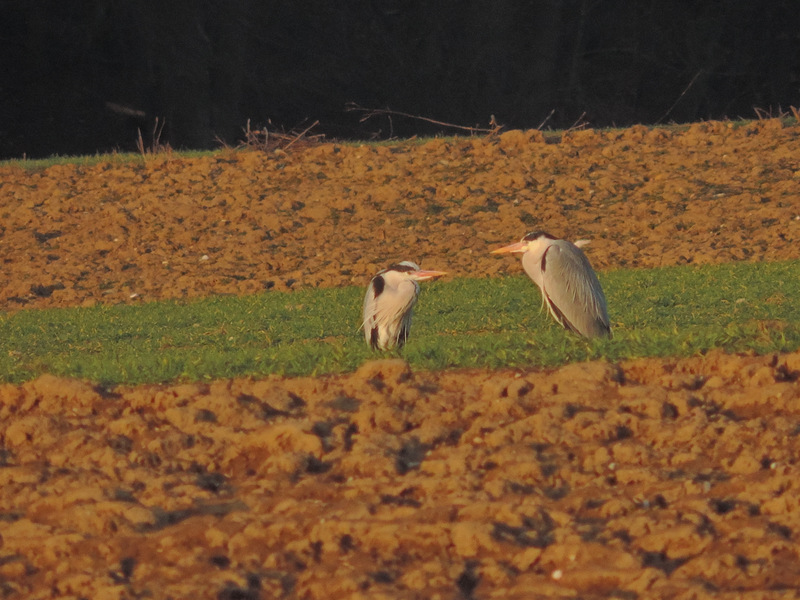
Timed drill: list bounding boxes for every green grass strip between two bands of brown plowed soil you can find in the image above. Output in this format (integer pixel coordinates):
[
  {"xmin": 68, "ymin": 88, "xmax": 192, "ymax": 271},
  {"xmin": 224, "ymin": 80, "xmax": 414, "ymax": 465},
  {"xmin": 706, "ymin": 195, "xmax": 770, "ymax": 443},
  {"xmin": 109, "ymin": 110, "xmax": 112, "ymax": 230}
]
[{"xmin": 0, "ymin": 261, "xmax": 800, "ymax": 384}]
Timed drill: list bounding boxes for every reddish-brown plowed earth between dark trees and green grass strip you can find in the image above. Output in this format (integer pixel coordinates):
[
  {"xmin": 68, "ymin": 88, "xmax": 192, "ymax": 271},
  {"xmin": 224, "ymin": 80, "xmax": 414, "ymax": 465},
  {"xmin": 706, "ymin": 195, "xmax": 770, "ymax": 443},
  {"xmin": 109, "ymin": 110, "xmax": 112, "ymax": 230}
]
[{"xmin": 0, "ymin": 120, "xmax": 800, "ymax": 310}]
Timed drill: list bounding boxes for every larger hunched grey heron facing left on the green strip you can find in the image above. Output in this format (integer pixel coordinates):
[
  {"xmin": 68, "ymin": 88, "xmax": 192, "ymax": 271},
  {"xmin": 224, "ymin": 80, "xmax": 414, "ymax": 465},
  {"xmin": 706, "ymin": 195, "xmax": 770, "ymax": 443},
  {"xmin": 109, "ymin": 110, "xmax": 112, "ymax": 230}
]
[{"xmin": 492, "ymin": 231, "xmax": 611, "ymax": 338}]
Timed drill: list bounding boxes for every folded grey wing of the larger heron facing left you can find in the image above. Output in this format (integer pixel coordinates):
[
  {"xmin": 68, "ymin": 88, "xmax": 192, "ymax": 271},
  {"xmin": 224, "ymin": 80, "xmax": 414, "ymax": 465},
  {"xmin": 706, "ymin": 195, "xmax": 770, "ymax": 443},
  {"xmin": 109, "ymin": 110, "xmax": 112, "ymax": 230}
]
[{"xmin": 542, "ymin": 240, "xmax": 611, "ymax": 337}]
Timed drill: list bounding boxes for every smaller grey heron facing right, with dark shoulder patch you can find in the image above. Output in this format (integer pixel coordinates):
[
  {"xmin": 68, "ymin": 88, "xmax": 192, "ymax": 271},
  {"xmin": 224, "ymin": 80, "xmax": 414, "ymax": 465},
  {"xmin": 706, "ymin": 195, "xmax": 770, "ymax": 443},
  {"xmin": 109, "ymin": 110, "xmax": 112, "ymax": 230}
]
[{"xmin": 363, "ymin": 260, "xmax": 445, "ymax": 350}]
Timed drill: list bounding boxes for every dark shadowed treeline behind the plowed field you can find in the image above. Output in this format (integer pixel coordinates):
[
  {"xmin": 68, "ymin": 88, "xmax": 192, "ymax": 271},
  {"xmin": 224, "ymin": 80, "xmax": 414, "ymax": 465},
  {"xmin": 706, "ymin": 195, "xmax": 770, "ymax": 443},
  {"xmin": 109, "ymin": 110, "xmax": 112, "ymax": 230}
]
[{"xmin": 0, "ymin": 0, "xmax": 800, "ymax": 157}]
